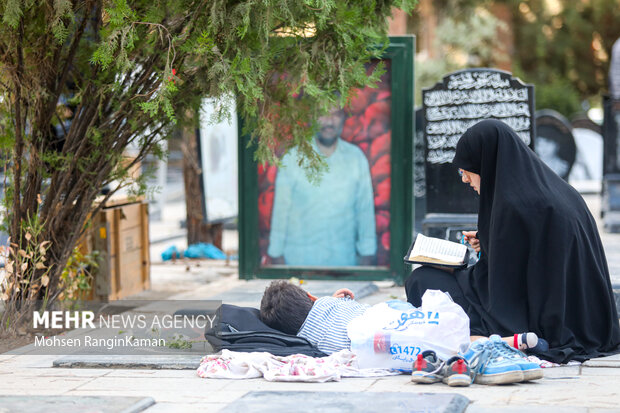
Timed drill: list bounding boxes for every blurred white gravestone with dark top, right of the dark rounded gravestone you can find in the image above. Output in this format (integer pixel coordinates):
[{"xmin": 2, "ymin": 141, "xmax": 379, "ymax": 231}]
[{"xmin": 569, "ymin": 115, "xmax": 603, "ymax": 182}]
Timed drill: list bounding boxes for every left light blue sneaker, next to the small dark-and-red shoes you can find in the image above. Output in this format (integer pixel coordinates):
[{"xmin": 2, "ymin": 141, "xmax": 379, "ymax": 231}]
[{"xmin": 462, "ymin": 338, "xmax": 523, "ymax": 384}]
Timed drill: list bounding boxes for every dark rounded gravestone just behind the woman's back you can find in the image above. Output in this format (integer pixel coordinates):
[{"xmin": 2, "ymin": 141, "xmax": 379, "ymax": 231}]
[{"xmin": 535, "ymin": 109, "xmax": 577, "ymax": 181}]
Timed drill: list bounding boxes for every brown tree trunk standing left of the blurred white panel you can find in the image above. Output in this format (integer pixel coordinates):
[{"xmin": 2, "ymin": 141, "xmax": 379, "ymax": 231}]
[{"xmin": 181, "ymin": 128, "xmax": 222, "ymax": 249}]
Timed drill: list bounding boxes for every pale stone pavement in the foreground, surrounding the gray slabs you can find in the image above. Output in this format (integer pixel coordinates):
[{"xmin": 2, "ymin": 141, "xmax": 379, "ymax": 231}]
[{"xmin": 0, "ymin": 355, "xmax": 620, "ymax": 413}]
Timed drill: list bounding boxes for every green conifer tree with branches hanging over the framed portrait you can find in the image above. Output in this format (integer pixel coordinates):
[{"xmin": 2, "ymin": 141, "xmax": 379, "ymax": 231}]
[{"xmin": 0, "ymin": 0, "xmax": 416, "ymax": 306}]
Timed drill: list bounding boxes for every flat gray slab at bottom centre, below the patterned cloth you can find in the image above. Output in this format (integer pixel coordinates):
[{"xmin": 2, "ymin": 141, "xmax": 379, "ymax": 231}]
[{"xmin": 220, "ymin": 391, "xmax": 469, "ymax": 413}]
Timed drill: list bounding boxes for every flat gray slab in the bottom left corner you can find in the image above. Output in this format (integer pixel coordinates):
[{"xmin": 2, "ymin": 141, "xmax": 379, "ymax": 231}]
[{"xmin": 0, "ymin": 396, "xmax": 155, "ymax": 413}]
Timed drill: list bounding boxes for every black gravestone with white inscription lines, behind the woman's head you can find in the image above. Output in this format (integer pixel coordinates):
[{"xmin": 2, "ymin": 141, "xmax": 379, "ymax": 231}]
[{"xmin": 422, "ymin": 68, "xmax": 535, "ymax": 240}]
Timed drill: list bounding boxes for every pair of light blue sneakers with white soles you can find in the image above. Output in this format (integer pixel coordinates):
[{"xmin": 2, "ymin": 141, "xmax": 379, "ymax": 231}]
[{"xmin": 463, "ymin": 334, "xmax": 543, "ymax": 384}]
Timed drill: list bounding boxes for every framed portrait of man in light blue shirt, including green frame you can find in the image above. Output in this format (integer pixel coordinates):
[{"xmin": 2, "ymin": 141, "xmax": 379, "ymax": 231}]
[{"xmin": 239, "ymin": 36, "xmax": 415, "ymax": 280}]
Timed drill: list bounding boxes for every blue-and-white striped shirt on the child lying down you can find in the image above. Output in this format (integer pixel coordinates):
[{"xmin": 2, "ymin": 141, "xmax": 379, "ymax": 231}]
[{"xmin": 297, "ymin": 297, "xmax": 370, "ymax": 354}]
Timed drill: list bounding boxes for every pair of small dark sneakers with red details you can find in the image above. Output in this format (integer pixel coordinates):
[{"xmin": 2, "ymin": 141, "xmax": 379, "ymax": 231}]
[{"xmin": 411, "ymin": 350, "xmax": 472, "ymax": 387}]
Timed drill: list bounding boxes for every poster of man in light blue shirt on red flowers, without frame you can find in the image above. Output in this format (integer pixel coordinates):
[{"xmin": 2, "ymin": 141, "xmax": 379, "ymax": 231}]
[{"xmin": 257, "ymin": 61, "xmax": 392, "ymax": 267}]
